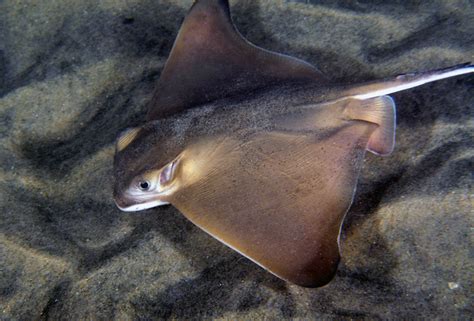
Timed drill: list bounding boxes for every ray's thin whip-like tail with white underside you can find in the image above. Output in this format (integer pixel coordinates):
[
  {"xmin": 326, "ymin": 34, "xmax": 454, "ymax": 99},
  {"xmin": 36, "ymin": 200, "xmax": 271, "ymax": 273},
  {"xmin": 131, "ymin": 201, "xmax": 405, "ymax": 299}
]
[{"xmin": 347, "ymin": 62, "xmax": 474, "ymax": 99}]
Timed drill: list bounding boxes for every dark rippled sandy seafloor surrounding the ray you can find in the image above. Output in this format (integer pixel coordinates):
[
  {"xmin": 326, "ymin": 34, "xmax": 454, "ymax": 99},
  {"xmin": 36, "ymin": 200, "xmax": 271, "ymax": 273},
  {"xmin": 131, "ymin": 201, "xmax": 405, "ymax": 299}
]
[{"xmin": 0, "ymin": 0, "xmax": 474, "ymax": 320}]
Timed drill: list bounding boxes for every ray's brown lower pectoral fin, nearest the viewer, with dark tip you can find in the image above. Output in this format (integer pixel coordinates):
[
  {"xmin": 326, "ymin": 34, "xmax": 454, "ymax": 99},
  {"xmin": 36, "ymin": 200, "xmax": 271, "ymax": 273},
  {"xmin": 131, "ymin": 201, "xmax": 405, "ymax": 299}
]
[{"xmin": 165, "ymin": 131, "xmax": 375, "ymax": 287}]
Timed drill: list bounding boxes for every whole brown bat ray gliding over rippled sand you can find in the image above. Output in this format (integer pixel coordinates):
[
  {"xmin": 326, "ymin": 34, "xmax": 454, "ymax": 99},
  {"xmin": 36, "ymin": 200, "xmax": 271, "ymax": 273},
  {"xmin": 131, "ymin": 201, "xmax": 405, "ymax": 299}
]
[{"xmin": 114, "ymin": 0, "xmax": 474, "ymax": 287}]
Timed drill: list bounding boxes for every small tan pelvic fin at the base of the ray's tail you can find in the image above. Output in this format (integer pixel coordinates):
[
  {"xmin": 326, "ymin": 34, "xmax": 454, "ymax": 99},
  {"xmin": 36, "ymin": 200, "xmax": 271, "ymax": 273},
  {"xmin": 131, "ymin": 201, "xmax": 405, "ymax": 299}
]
[{"xmin": 343, "ymin": 96, "xmax": 396, "ymax": 156}]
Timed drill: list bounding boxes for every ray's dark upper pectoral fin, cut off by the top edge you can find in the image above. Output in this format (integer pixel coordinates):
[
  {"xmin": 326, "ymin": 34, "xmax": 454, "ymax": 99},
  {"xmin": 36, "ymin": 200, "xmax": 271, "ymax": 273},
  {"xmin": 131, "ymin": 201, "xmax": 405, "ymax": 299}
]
[{"xmin": 147, "ymin": 0, "xmax": 326, "ymax": 121}]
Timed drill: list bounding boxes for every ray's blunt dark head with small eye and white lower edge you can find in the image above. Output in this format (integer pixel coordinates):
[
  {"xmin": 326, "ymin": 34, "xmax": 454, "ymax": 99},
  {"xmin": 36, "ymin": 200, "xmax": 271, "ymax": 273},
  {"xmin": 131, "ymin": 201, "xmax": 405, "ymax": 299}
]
[{"xmin": 114, "ymin": 122, "xmax": 182, "ymax": 212}]
